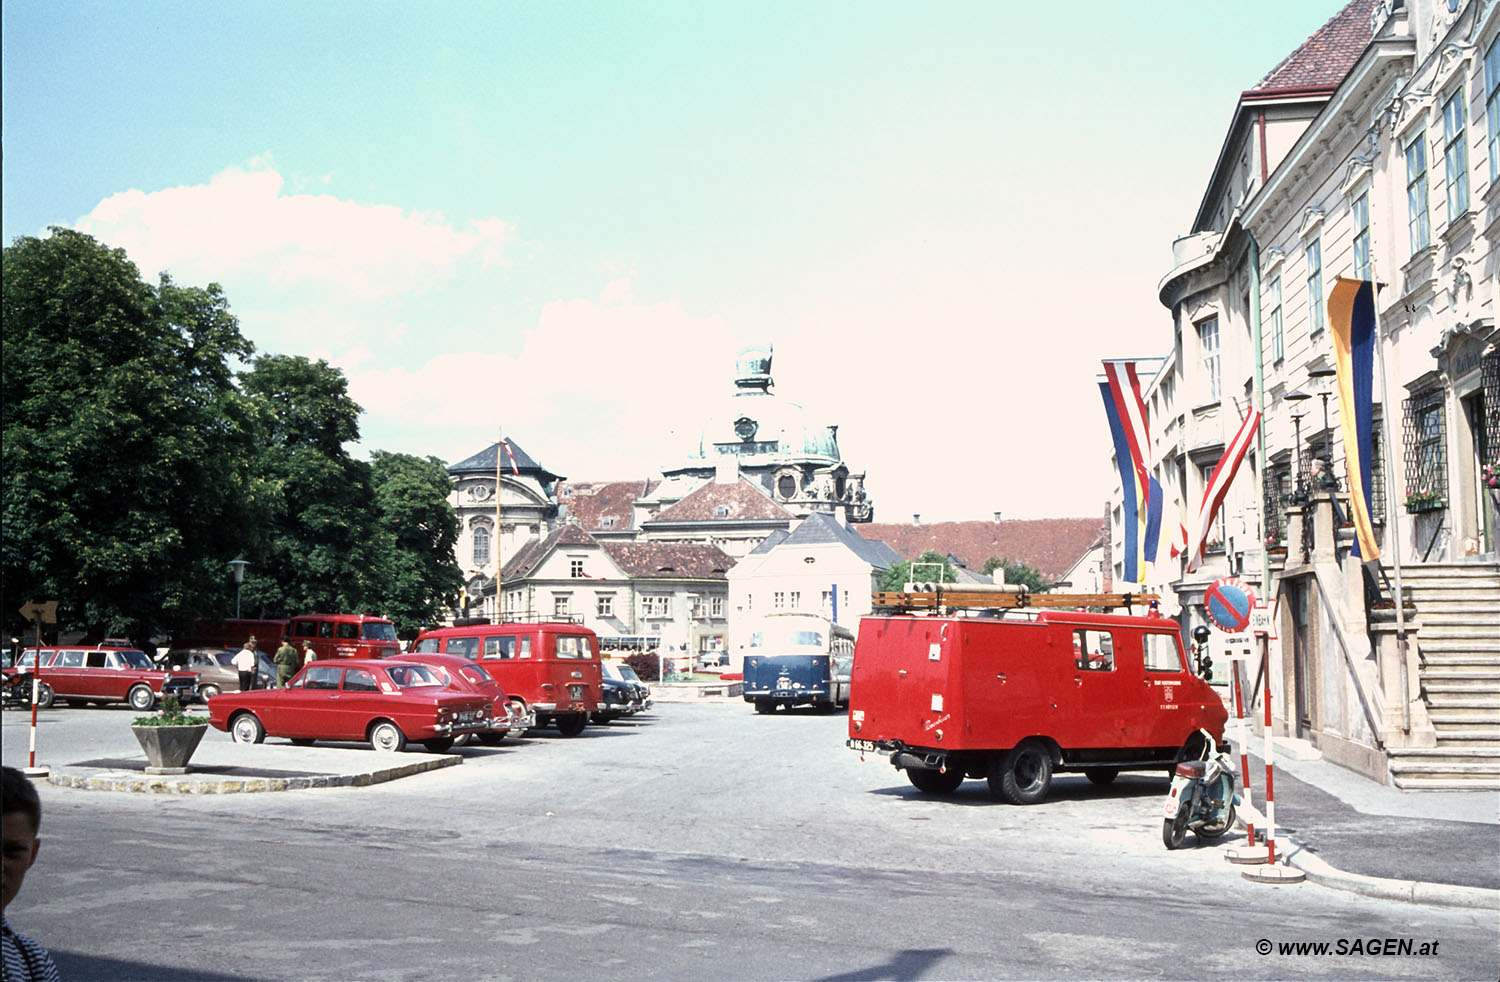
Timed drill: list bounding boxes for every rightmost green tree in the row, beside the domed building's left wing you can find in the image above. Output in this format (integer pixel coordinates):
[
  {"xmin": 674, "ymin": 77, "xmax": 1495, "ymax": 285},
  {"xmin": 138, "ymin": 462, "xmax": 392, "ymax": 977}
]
[{"xmin": 371, "ymin": 450, "xmax": 464, "ymax": 636}]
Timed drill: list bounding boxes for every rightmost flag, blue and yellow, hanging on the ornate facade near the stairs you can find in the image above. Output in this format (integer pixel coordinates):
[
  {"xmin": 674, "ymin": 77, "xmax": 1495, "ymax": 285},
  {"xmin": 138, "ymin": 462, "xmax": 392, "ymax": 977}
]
[{"xmin": 1328, "ymin": 276, "xmax": 1380, "ymax": 562}]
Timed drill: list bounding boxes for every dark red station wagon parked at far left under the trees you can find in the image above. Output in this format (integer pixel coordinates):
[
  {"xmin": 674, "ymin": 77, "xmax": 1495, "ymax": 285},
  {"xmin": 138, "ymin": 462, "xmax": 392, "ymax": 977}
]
[{"xmin": 17, "ymin": 645, "xmax": 197, "ymax": 712}]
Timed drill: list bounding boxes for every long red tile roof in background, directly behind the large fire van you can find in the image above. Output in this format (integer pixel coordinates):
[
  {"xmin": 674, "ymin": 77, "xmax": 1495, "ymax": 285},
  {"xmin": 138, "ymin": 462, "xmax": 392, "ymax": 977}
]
[{"xmin": 860, "ymin": 519, "xmax": 1109, "ymax": 580}]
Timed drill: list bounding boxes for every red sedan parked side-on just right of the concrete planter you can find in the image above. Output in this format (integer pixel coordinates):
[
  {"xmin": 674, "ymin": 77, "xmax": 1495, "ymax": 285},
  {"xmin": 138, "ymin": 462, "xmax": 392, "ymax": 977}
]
[{"xmin": 209, "ymin": 658, "xmax": 494, "ymax": 754}]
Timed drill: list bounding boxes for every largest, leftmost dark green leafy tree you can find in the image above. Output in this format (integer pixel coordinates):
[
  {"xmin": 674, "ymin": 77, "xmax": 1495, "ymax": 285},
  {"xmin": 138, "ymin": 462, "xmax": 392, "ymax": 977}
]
[{"xmin": 0, "ymin": 228, "xmax": 263, "ymax": 640}]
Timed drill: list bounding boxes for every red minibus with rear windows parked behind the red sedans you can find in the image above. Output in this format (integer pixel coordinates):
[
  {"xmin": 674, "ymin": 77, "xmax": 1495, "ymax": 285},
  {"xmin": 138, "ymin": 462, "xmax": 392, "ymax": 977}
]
[{"xmin": 411, "ymin": 621, "xmax": 602, "ymax": 736}]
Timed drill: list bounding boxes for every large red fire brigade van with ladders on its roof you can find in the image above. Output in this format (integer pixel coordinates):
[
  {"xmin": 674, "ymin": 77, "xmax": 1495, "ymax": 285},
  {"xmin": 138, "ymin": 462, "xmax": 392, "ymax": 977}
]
[{"xmin": 849, "ymin": 610, "xmax": 1229, "ymax": 805}]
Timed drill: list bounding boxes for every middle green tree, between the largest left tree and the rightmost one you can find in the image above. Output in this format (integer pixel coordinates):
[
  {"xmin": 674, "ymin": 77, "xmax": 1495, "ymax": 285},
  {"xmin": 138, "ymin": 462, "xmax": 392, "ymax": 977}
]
[{"xmin": 240, "ymin": 355, "xmax": 387, "ymax": 616}]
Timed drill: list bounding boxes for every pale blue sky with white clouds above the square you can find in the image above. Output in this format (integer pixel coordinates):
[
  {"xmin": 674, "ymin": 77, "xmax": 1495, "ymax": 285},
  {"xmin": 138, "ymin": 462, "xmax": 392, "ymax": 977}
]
[{"xmin": 0, "ymin": 0, "xmax": 1341, "ymax": 523}]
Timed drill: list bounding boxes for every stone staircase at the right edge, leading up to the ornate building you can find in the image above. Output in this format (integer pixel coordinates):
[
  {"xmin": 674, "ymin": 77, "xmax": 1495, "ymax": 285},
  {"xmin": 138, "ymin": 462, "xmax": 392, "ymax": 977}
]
[{"xmin": 1388, "ymin": 562, "xmax": 1500, "ymax": 790}]
